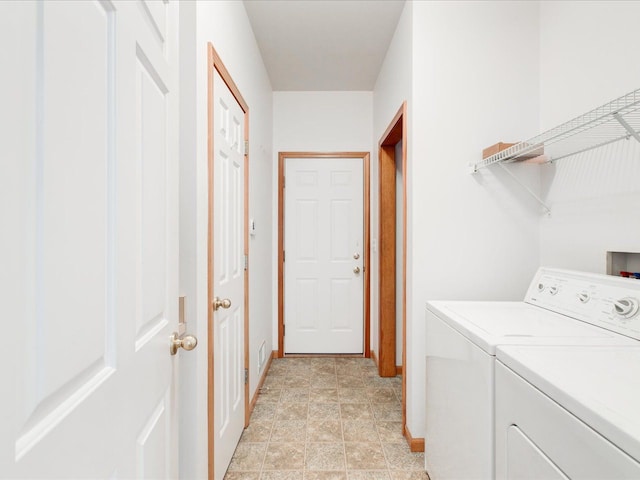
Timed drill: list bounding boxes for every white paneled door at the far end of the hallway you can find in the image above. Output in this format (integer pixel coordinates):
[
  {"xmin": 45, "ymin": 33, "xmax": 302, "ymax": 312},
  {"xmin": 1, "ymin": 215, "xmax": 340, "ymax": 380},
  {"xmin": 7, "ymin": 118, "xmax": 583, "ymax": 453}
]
[{"xmin": 284, "ymin": 158, "xmax": 364, "ymax": 354}]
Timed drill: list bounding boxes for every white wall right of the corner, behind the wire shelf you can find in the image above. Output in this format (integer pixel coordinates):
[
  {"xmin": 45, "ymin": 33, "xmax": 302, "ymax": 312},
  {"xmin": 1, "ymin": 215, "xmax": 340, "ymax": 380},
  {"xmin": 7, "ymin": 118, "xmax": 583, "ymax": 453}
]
[{"xmin": 540, "ymin": 1, "xmax": 640, "ymax": 273}]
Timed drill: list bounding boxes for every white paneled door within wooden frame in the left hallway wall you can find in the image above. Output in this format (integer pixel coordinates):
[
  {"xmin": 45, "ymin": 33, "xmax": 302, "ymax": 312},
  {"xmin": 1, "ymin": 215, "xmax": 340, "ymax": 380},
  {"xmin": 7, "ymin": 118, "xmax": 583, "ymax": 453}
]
[{"xmin": 211, "ymin": 70, "xmax": 245, "ymax": 479}]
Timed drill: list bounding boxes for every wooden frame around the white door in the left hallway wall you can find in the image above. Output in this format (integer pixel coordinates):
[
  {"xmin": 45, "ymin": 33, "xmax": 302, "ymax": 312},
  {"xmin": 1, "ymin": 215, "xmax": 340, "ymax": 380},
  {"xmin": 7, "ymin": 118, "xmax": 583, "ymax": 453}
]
[{"xmin": 207, "ymin": 43, "xmax": 250, "ymax": 480}]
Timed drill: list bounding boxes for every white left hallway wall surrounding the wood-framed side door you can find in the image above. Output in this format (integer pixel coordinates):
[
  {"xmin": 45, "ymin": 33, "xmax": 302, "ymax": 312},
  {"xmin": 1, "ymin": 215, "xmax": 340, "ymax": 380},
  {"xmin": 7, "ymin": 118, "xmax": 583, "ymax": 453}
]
[{"xmin": 180, "ymin": 1, "xmax": 273, "ymax": 478}]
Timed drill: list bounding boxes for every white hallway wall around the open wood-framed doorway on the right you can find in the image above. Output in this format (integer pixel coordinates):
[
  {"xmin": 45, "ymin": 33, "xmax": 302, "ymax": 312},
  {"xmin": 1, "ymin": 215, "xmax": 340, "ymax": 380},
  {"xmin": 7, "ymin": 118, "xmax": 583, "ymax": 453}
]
[{"xmin": 371, "ymin": 2, "xmax": 413, "ymax": 365}]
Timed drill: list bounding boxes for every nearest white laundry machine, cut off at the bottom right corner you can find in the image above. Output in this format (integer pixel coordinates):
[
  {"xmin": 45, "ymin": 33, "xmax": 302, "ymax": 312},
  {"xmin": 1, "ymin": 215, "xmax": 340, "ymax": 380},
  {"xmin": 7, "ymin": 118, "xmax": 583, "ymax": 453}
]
[{"xmin": 496, "ymin": 342, "xmax": 640, "ymax": 480}]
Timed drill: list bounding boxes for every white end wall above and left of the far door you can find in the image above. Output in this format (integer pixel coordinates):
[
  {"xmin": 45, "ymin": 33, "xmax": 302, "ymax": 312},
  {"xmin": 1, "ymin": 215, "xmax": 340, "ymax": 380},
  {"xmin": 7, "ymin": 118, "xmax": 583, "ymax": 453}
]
[{"xmin": 272, "ymin": 92, "xmax": 373, "ymax": 349}]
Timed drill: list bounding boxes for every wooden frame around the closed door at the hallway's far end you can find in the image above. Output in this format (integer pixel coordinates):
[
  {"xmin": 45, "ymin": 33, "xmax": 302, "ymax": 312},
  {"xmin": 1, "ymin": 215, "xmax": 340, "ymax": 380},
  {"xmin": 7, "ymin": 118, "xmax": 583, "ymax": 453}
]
[{"xmin": 278, "ymin": 152, "xmax": 371, "ymax": 358}]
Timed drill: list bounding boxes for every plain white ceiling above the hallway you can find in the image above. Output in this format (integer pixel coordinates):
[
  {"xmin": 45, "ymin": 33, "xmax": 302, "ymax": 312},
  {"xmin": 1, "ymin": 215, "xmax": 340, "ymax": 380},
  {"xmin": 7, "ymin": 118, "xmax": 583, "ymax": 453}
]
[{"xmin": 244, "ymin": 0, "xmax": 404, "ymax": 91}]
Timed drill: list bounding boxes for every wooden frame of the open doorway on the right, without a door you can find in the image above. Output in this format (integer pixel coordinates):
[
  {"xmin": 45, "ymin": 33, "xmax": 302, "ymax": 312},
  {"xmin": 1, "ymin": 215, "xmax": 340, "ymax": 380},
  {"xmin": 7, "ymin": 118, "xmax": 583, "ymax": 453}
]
[{"xmin": 378, "ymin": 101, "xmax": 407, "ymax": 428}]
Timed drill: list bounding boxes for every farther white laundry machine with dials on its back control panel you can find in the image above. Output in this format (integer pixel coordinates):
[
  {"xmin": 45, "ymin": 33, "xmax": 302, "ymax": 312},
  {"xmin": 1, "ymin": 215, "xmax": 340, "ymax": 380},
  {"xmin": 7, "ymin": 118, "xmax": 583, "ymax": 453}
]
[{"xmin": 425, "ymin": 268, "xmax": 640, "ymax": 480}]
